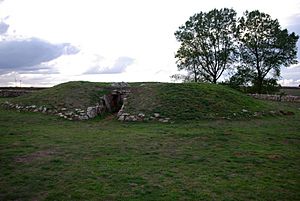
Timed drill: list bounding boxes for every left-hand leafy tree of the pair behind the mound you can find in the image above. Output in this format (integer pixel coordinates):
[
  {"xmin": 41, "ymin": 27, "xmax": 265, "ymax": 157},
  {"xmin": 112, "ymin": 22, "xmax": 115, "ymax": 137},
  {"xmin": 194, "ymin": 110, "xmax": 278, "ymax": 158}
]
[{"xmin": 175, "ymin": 8, "xmax": 236, "ymax": 83}]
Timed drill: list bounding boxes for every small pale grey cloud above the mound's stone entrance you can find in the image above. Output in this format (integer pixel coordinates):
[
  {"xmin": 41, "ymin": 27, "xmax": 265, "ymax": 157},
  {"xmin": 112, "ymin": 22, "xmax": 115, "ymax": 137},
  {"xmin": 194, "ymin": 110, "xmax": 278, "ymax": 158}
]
[{"xmin": 84, "ymin": 57, "xmax": 134, "ymax": 74}]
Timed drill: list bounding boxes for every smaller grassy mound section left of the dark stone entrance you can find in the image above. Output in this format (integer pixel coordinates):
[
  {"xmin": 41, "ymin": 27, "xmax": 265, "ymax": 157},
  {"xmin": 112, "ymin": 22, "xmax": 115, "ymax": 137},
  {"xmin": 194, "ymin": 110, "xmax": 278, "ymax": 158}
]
[{"xmin": 10, "ymin": 81, "xmax": 109, "ymax": 109}]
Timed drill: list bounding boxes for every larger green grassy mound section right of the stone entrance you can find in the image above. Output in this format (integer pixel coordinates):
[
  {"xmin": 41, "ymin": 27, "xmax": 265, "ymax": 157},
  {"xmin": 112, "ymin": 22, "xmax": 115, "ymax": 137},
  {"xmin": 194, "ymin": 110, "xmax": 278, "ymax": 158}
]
[{"xmin": 125, "ymin": 83, "xmax": 270, "ymax": 120}]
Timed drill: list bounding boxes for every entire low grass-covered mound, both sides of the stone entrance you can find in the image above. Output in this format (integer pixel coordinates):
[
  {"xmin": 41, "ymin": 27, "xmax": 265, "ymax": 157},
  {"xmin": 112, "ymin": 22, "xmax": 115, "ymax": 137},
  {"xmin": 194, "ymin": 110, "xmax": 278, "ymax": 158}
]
[{"xmin": 4, "ymin": 81, "xmax": 271, "ymax": 120}]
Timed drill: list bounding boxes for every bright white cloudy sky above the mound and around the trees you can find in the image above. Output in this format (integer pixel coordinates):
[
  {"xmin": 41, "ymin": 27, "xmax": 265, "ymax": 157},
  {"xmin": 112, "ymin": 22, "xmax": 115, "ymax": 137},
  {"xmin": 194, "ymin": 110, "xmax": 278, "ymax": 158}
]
[{"xmin": 0, "ymin": 0, "xmax": 300, "ymax": 86}]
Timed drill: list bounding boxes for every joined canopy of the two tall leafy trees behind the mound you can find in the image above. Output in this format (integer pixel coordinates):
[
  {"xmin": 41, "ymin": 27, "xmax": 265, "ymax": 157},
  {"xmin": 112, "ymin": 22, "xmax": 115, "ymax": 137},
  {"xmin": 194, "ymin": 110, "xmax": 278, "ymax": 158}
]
[{"xmin": 175, "ymin": 8, "xmax": 299, "ymax": 93}]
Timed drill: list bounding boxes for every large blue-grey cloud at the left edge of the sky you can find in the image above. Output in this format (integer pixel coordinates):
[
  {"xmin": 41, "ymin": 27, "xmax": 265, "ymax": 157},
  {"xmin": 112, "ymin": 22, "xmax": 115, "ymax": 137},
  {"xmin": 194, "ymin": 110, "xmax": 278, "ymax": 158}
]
[{"xmin": 0, "ymin": 38, "xmax": 79, "ymax": 73}]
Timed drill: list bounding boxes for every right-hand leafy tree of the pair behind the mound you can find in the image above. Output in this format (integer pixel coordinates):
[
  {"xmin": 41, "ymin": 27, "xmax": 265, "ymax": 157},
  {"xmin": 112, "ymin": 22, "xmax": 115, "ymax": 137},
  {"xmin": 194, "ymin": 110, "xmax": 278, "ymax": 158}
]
[{"xmin": 237, "ymin": 10, "xmax": 299, "ymax": 93}]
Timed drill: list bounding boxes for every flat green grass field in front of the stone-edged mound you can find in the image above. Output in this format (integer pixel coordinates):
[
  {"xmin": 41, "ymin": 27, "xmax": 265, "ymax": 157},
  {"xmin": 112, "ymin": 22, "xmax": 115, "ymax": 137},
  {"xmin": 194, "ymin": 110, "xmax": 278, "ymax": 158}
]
[{"xmin": 0, "ymin": 103, "xmax": 300, "ymax": 201}]
